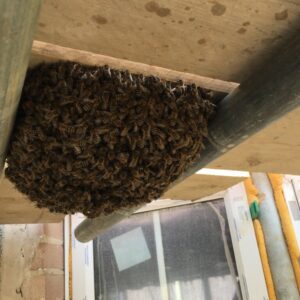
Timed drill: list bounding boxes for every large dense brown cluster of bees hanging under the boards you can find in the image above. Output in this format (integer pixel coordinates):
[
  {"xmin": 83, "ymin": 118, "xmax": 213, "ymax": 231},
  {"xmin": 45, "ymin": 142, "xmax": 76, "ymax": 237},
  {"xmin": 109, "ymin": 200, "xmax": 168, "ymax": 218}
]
[{"xmin": 6, "ymin": 62, "xmax": 214, "ymax": 218}]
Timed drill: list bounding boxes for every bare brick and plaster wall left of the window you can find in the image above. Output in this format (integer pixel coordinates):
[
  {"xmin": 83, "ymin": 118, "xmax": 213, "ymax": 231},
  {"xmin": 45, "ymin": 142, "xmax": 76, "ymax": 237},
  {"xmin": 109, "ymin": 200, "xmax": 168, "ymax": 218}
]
[{"xmin": 0, "ymin": 223, "xmax": 64, "ymax": 300}]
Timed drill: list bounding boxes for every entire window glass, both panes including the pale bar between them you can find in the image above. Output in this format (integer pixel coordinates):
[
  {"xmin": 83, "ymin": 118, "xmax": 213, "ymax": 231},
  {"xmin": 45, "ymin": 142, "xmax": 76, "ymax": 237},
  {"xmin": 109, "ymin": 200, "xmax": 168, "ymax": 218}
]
[{"xmin": 94, "ymin": 200, "xmax": 238, "ymax": 300}]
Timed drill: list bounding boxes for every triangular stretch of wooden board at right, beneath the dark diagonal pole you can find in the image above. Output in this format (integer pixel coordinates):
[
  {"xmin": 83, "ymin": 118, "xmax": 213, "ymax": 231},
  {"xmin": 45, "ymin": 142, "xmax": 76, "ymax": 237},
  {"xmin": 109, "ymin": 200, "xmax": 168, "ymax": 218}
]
[{"xmin": 207, "ymin": 108, "xmax": 300, "ymax": 175}]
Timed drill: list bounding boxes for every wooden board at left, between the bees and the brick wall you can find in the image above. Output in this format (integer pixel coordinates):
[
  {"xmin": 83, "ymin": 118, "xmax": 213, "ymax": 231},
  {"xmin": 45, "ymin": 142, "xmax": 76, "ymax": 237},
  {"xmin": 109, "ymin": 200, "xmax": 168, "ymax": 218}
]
[{"xmin": 0, "ymin": 179, "xmax": 64, "ymax": 224}]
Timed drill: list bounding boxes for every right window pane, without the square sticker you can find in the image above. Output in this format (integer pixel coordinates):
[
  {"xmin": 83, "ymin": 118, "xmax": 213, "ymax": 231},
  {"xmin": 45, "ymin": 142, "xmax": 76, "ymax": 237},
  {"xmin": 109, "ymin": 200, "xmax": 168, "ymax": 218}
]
[{"xmin": 160, "ymin": 200, "xmax": 236, "ymax": 300}]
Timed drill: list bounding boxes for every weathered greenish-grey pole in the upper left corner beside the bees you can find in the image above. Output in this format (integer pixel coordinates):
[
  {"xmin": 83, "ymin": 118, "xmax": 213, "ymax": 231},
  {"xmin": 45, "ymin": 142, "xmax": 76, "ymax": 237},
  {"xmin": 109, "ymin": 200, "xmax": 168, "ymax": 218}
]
[{"xmin": 0, "ymin": 0, "xmax": 41, "ymax": 172}]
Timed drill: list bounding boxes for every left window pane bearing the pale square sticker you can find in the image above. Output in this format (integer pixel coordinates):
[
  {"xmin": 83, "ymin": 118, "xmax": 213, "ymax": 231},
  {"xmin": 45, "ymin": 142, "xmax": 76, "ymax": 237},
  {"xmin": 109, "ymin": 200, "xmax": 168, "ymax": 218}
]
[{"xmin": 94, "ymin": 213, "xmax": 160, "ymax": 300}]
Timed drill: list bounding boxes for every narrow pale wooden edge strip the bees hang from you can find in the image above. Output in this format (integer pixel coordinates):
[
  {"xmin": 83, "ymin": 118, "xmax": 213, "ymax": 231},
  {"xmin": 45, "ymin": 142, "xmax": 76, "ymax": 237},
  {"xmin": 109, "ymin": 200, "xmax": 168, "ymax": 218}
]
[{"xmin": 30, "ymin": 41, "xmax": 238, "ymax": 93}]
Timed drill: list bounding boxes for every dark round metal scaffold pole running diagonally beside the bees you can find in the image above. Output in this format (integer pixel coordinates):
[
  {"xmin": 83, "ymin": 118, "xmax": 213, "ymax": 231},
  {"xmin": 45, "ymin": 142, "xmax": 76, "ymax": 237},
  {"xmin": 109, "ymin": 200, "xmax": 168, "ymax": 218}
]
[{"xmin": 75, "ymin": 27, "xmax": 300, "ymax": 242}]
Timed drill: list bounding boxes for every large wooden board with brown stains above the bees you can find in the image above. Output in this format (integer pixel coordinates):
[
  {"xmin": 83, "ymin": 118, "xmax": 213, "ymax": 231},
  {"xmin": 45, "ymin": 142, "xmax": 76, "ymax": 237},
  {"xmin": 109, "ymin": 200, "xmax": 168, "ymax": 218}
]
[{"xmin": 35, "ymin": 0, "xmax": 300, "ymax": 82}]
